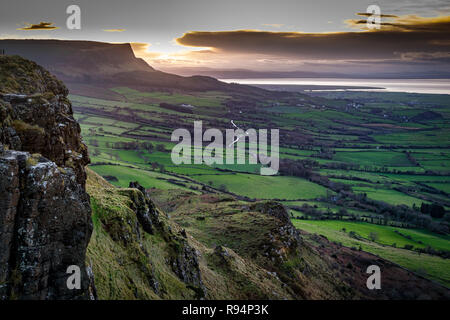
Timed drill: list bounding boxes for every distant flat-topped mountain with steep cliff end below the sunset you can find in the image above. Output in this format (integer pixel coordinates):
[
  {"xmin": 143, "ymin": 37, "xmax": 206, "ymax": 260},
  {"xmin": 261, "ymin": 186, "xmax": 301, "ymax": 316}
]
[{"xmin": 0, "ymin": 40, "xmax": 264, "ymax": 94}]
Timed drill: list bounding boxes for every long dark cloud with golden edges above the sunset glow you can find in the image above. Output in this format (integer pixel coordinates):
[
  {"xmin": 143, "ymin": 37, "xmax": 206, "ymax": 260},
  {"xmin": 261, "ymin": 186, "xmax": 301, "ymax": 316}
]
[{"xmin": 176, "ymin": 16, "xmax": 450, "ymax": 60}]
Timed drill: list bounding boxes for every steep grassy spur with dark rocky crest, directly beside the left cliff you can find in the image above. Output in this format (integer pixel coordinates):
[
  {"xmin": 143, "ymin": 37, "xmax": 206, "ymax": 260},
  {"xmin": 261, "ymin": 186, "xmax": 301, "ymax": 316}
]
[{"xmin": 86, "ymin": 170, "xmax": 206, "ymax": 299}]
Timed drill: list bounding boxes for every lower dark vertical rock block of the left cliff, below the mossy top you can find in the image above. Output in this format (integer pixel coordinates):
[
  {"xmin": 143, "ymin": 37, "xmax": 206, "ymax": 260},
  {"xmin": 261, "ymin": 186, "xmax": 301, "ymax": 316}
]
[{"xmin": 0, "ymin": 151, "xmax": 92, "ymax": 299}]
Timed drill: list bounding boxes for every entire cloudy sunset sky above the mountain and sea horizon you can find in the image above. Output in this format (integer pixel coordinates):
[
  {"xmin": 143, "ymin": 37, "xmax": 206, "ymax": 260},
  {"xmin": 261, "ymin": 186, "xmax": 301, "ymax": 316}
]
[{"xmin": 0, "ymin": 0, "xmax": 450, "ymax": 74}]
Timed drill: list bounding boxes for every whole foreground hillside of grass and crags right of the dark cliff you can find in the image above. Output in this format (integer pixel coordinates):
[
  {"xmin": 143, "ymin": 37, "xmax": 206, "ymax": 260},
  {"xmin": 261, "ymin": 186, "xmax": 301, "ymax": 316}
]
[{"xmin": 87, "ymin": 170, "xmax": 449, "ymax": 299}]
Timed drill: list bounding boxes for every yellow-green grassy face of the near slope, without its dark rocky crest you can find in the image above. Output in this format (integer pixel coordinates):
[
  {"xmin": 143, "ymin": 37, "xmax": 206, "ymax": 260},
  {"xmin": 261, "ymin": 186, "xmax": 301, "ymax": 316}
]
[{"xmin": 87, "ymin": 170, "xmax": 200, "ymax": 299}]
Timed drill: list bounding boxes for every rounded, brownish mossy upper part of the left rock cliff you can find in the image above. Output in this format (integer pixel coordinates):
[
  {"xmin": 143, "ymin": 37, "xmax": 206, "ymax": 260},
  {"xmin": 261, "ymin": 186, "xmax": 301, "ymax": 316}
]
[{"xmin": 0, "ymin": 56, "xmax": 89, "ymax": 186}]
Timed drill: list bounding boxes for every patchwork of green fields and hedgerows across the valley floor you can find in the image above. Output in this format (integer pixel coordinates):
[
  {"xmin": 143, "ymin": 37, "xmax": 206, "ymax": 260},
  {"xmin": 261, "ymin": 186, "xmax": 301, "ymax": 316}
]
[{"xmin": 70, "ymin": 87, "xmax": 450, "ymax": 286}]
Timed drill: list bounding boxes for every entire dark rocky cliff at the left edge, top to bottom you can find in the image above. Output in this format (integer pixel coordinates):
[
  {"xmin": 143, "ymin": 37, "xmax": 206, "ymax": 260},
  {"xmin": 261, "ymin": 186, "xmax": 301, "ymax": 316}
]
[{"xmin": 0, "ymin": 56, "xmax": 92, "ymax": 299}]
